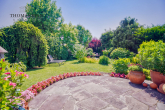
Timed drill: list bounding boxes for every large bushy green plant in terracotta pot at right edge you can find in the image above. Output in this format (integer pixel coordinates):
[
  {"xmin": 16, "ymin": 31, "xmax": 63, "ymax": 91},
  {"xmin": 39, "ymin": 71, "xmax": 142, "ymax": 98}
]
[{"xmin": 137, "ymin": 40, "xmax": 165, "ymax": 87}]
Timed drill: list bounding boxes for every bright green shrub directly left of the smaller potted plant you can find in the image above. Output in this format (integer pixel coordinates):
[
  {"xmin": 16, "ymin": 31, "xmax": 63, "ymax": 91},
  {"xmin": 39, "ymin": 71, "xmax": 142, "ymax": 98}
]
[{"xmin": 112, "ymin": 58, "xmax": 130, "ymax": 74}]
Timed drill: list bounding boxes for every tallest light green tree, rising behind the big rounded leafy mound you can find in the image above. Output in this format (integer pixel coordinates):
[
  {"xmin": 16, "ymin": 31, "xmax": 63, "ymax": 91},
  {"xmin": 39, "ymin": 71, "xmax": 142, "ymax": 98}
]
[{"xmin": 26, "ymin": 0, "xmax": 63, "ymax": 35}]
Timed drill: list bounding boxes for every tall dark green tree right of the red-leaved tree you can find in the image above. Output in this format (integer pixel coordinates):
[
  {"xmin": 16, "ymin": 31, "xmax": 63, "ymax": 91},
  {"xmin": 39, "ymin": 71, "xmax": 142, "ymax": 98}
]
[{"xmin": 112, "ymin": 17, "xmax": 140, "ymax": 52}]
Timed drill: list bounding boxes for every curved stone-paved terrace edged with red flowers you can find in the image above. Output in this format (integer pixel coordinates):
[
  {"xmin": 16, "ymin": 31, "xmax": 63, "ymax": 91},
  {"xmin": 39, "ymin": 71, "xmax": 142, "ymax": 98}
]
[{"xmin": 29, "ymin": 75, "xmax": 165, "ymax": 110}]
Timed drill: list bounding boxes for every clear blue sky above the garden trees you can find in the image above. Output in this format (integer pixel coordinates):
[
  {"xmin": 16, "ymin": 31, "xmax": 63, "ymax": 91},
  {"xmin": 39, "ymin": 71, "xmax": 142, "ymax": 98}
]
[{"xmin": 0, "ymin": 0, "xmax": 165, "ymax": 38}]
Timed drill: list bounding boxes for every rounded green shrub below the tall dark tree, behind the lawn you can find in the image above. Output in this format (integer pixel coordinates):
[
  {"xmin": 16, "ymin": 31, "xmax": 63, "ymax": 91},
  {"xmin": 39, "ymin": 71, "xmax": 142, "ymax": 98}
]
[{"xmin": 110, "ymin": 47, "xmax": 130, "ymax": 59}]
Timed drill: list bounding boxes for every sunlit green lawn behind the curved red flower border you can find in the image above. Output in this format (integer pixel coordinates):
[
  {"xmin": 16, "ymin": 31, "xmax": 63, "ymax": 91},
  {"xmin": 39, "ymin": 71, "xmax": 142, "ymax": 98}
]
[{"xmin": 21, "ymin": 60, "xmax": 113, "ymax": 90}]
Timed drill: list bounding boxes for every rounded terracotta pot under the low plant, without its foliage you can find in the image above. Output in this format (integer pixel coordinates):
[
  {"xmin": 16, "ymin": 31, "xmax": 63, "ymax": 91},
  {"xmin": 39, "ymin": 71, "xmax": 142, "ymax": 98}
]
[{"xmin": 128, "ymin": 71, "xmax": 145, "ymax": 84}]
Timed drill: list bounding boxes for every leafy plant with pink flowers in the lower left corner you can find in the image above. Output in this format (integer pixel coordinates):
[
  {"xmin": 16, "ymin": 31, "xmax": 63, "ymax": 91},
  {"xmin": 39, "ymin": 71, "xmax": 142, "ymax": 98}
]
[{"xmin": 0, "ymin": 59, "xmax": 28, "ymax": 110}]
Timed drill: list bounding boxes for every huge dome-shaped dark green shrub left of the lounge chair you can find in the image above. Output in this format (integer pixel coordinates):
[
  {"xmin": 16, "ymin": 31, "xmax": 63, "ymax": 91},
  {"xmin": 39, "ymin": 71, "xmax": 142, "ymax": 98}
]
[{"xmin": 0, "ymin": 21, "xmax": 48, "ymax": 68}]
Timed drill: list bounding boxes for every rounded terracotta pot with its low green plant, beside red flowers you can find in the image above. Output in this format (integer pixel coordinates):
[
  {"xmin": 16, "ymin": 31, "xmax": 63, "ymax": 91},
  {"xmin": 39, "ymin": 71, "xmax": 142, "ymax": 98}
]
[{"xmin": 128, "ymin": 65, "xmax": 145, "ymax": 84}]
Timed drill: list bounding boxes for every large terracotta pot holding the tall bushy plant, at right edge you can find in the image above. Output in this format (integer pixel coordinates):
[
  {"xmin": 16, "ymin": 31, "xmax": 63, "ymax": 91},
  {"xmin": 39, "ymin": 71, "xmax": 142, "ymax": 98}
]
[{"xmin": 150, "ymin": 70, "xmax": 165, "ymax": 87}]
